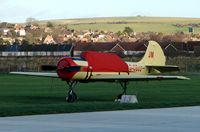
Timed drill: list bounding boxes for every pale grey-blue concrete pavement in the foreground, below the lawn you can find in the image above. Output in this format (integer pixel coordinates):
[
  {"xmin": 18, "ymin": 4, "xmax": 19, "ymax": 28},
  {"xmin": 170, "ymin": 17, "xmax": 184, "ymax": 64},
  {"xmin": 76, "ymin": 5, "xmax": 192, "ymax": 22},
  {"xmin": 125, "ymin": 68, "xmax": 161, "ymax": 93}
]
[{"xmin": 0, "ymin": 106, "xmax": 200, "ymax": 132}]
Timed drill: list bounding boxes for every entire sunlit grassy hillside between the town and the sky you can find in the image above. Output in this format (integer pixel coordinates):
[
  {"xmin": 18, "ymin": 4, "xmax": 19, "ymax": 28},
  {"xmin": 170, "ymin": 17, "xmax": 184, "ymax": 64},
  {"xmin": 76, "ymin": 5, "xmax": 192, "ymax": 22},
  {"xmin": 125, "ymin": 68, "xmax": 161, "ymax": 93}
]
[{"xmin": 40, "ymin": 17, "xmax": 200, "ymax": 33}]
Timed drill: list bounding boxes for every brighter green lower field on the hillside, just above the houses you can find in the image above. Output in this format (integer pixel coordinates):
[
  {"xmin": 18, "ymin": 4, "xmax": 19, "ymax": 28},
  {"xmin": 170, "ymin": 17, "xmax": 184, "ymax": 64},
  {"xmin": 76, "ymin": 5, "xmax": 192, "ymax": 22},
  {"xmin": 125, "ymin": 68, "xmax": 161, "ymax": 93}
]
[{"xmin": 68, "ymin": 23, "xmax": 191, "ymax": 33}]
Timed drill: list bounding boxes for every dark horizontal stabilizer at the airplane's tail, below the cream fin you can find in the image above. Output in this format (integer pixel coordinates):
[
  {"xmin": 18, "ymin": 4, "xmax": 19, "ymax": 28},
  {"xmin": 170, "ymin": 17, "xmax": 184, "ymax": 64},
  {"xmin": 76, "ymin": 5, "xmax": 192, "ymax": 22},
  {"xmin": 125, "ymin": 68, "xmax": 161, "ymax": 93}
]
[{"xmin": 146, "ymin": 65, "xmax": 180, "ymax": 73}]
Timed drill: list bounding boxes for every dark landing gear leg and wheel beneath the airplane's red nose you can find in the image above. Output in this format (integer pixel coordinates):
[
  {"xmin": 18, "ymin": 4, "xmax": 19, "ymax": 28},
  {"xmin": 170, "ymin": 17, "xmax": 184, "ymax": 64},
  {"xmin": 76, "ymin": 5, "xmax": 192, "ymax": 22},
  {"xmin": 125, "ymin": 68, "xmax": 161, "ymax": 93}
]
[{"xmin": 66, "ymin": 81, "xmax": 77, "ymax": 103}]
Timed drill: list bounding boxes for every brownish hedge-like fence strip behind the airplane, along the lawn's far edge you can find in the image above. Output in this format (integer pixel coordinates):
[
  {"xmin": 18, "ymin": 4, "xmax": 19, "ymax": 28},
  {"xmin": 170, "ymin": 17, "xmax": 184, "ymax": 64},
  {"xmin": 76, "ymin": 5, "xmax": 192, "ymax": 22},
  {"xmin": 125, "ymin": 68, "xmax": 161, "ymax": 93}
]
[{"xmin": 0, "ymin": 56, "xmax": 200, "ymax": 72}]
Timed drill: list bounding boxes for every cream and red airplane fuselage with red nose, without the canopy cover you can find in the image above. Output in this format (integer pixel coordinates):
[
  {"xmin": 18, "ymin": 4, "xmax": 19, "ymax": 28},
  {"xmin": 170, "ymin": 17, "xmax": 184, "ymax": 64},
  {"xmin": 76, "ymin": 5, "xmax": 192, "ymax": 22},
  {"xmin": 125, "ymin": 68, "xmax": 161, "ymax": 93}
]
[{"xmin": 57, "ymin": 57, "xmax": 149, "ymax": 80}]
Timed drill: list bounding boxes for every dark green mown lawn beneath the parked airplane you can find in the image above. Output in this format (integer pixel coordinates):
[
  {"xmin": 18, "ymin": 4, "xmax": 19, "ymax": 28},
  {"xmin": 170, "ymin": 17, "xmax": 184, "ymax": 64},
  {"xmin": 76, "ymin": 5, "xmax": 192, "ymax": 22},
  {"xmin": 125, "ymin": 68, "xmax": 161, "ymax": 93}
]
[{"xmin": 0, "ymin": 74, "xmax": 200, "ymax": 116}]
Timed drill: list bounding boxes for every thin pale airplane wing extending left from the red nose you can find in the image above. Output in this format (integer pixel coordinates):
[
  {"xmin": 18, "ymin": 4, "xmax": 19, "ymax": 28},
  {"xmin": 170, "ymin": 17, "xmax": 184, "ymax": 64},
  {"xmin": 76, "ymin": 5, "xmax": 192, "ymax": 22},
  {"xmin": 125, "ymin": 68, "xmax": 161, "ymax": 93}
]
[{"xmin": 10, "ymin": 72, "xmax": 58, "ymax": 77}]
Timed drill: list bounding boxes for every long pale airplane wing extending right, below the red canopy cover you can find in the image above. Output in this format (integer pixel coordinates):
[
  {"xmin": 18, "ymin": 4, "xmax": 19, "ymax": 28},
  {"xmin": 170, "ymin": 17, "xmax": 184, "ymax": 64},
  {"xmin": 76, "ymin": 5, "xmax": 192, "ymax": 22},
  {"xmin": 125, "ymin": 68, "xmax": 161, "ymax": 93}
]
[{"xmin": 91, "ymin": 75, "xmax": 189, "ymax": 81}]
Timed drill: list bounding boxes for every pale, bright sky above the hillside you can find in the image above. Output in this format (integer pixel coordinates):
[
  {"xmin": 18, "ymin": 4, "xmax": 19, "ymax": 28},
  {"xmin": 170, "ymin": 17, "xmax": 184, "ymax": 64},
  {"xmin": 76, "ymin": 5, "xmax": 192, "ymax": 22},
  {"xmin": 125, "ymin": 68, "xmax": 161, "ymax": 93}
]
[{"xmin": 0, "ymin": 0, "xmax": 200, "ymax": 22}]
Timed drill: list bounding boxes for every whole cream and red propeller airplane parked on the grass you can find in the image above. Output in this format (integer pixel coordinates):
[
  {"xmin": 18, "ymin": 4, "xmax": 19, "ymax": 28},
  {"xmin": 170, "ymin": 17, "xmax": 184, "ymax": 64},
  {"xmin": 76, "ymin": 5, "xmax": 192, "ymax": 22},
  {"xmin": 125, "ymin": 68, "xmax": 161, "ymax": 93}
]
[{"xmin": 10, "ymin": 41, "xmax": 189, "ymax": 103}]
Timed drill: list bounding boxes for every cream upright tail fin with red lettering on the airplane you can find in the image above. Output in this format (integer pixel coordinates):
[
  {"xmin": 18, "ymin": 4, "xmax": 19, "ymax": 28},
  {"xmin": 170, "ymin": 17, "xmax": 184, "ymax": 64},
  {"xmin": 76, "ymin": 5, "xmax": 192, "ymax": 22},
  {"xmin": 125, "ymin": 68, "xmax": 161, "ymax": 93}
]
[{"xmin": 139, "ymin": 41, "xmax": 166, "ymax": 66}]
